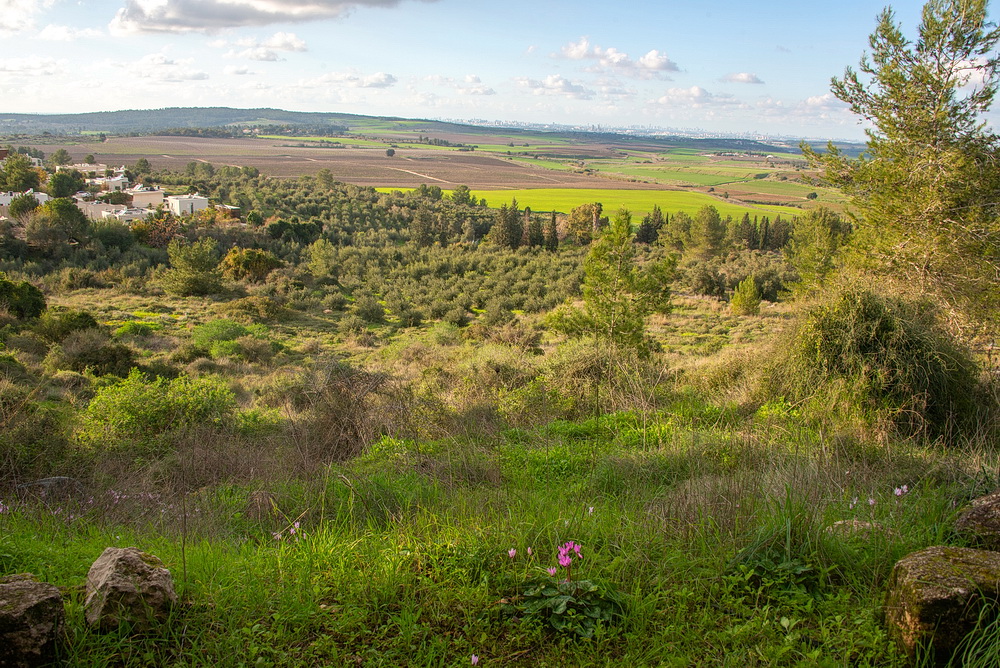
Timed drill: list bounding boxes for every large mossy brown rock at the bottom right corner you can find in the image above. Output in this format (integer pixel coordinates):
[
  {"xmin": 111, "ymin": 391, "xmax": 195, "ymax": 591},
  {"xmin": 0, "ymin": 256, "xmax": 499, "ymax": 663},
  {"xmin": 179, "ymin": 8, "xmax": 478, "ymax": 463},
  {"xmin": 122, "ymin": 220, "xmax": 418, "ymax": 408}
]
[{"xmin": 885, "ymin": 547, "xmax": 1000, "ymax": 663}]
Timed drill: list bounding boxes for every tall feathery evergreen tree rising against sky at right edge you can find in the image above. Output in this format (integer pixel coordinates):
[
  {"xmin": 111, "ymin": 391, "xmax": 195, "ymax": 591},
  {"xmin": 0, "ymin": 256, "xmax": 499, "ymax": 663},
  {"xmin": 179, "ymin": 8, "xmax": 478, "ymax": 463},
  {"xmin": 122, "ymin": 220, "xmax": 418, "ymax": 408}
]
[{"xmin": 803, "ymin": 0, "xmax": 1000, "ymax": 318}]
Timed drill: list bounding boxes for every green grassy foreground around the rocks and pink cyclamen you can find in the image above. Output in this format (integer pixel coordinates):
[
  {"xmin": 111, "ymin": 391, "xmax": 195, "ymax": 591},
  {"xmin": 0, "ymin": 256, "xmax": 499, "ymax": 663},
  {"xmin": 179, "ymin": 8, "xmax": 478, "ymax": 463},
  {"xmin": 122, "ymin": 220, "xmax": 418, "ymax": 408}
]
[{"xmin": 0, "ymin": 399, "xmax": 998, "ymax": 666}]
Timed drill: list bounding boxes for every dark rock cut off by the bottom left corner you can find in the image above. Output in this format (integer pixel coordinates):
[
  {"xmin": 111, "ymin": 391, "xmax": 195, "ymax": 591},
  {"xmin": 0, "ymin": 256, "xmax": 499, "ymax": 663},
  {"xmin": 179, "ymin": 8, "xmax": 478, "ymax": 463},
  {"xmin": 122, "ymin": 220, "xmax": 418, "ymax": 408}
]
[{"xmin": 0, "ymin": 574, "xmax": 66, "ymax": 668}]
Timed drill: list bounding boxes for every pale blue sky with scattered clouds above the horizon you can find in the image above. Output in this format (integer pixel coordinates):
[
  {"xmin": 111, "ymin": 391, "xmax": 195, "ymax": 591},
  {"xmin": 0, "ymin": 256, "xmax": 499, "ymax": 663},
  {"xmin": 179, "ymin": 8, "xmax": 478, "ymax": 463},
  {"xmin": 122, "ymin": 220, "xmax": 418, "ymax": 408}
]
[{"xmin": 0, "ymin": 0, "xmax": 976, "ymax": 140}]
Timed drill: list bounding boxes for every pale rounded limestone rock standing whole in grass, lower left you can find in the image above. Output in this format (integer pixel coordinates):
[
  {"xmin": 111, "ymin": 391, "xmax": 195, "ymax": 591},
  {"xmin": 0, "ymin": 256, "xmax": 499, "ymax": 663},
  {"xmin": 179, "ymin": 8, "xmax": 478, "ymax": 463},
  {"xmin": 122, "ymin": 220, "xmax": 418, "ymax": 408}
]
[{"xmin": 84, "ymin": 547, "xmax": 177, "ymax": 631}]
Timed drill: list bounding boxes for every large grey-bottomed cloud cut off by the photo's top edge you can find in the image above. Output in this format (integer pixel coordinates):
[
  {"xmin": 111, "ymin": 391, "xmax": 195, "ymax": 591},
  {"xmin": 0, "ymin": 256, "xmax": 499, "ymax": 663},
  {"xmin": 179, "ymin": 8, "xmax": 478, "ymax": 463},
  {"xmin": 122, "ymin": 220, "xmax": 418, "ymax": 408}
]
[{"xmin": 111, "ymin": 0, "xmax": 433, "ymax": 32}]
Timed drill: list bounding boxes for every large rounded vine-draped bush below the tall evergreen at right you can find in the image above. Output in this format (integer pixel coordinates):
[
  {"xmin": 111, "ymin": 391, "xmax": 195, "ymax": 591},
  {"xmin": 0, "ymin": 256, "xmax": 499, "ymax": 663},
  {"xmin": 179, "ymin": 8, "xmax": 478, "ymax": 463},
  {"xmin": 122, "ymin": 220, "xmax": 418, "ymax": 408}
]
[{"xmin": 769, "ymin": 290, "xmax": 978, "ymax": 437}]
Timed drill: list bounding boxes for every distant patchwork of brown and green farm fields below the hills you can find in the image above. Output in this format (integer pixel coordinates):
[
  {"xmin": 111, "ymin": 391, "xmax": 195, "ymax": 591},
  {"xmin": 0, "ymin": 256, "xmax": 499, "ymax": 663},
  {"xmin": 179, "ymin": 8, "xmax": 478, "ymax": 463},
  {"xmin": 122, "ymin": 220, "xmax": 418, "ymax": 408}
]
[{"xmin": 11, "ymin": 118, "xmax": 842, "ymax": 215}]
